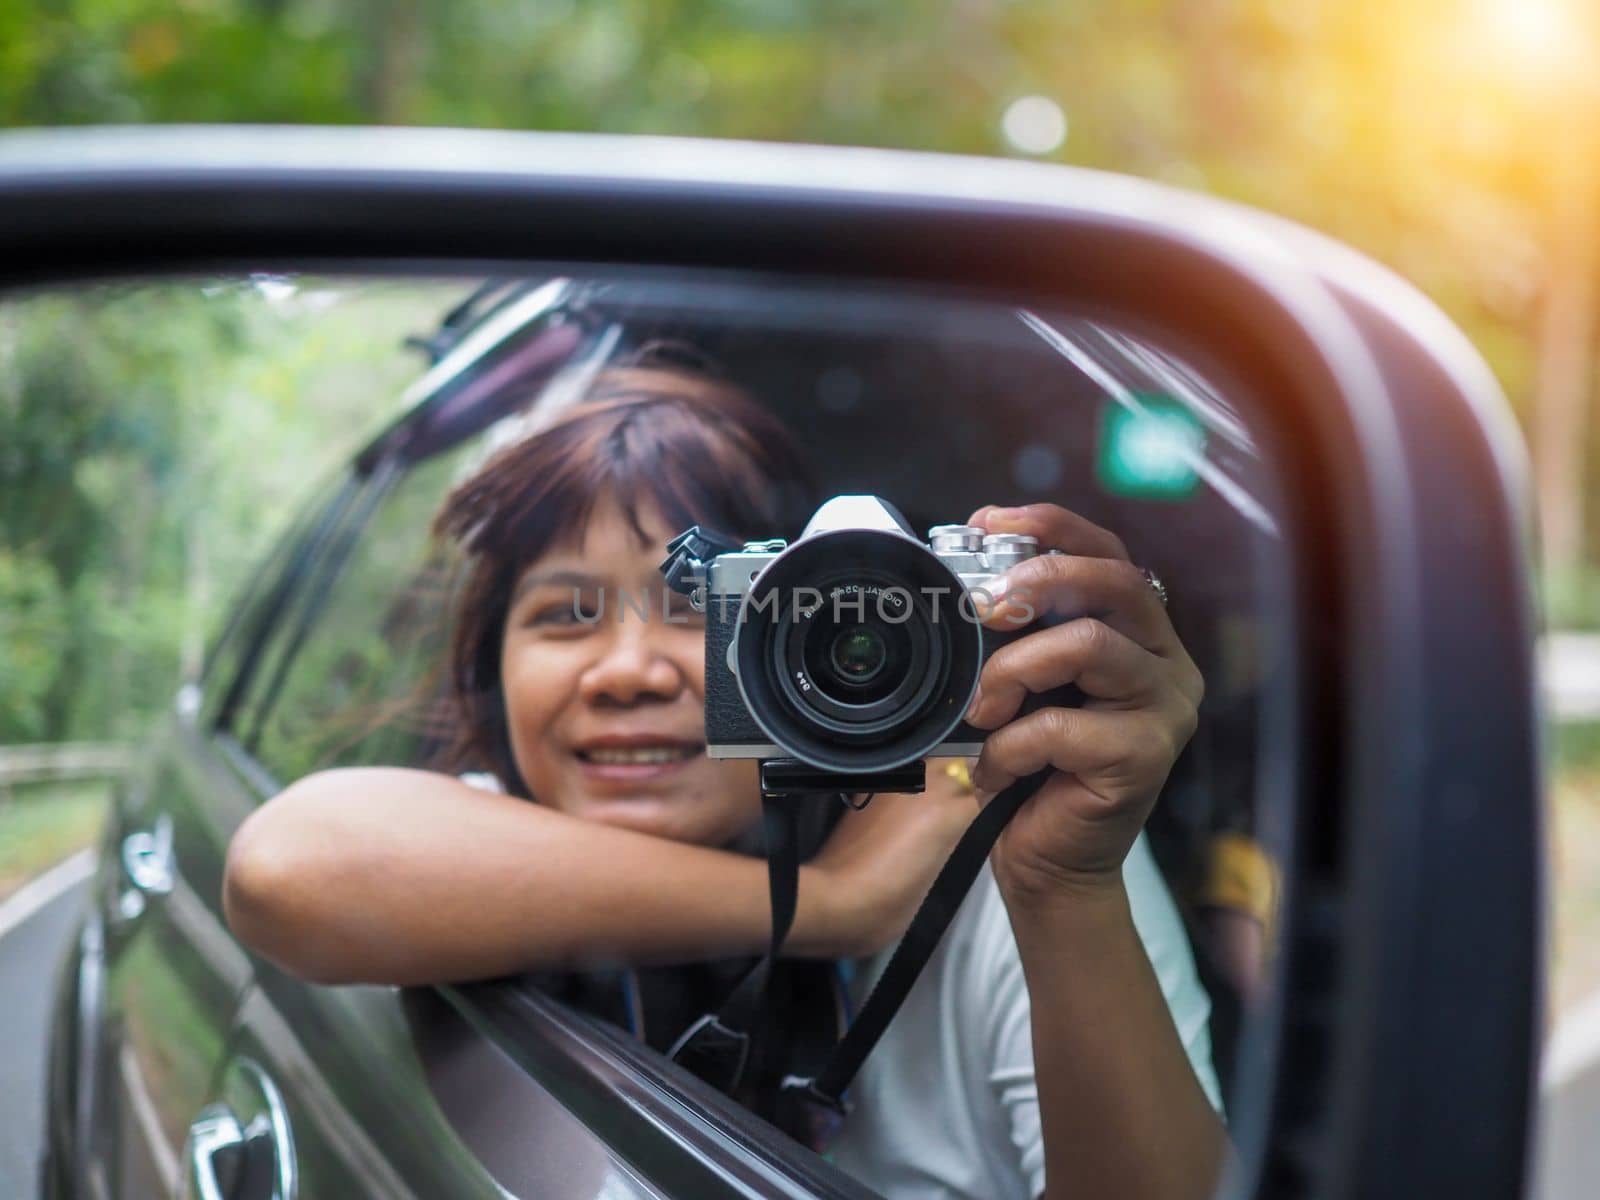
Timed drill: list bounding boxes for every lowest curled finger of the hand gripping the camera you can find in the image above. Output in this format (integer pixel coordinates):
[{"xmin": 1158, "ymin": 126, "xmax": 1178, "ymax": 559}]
[{"xmin": 973, "ymin": 709, "xmax": 1194, "ymax": 806}]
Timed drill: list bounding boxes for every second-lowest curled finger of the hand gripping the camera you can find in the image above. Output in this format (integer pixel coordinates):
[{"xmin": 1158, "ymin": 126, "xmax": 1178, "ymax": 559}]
[{"xmin": 966, "ymin": 618, "xmax": 1178, "ymax": 730}]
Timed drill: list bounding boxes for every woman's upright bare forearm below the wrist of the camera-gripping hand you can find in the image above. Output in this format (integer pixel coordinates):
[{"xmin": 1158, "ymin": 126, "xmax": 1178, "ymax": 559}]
[{"xmin": 1006, "ymin": 880, "xmax": 1227, "ymax": 1200}]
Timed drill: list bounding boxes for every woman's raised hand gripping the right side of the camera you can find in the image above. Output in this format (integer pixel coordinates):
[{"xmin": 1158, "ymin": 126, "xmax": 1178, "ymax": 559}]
[{"xmin": 968, "ymin": 504, "xmax": 1205, "ymax": 896}]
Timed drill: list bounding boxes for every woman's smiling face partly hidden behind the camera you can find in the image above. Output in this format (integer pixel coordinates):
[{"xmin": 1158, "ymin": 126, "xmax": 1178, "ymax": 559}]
[{"xmin": 501, "ymin": 501, "xmax": 760, "ymax": 845}]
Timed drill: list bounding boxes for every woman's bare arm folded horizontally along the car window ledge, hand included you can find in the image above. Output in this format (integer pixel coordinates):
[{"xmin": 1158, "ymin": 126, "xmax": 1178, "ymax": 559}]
[{"xmin": 224, "ymin": 768, "xmax": 973, "ymax": 984}]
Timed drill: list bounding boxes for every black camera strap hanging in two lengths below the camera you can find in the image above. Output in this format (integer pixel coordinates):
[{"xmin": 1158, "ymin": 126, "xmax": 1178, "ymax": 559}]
[{"xmin": 669, "ymin": 768, "xmax": 1053, "ymax": 1114}]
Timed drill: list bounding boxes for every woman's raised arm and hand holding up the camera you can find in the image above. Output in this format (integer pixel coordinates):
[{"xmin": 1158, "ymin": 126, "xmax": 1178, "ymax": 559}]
[{"xmin": 968, "ymin": 504, "xmax": 1227, "ymax": 1200}]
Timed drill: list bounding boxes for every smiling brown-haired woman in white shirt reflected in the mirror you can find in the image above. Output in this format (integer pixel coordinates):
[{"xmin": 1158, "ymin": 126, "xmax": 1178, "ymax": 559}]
[{"xmin": 226, "ymin": 352, "xmax": 1226, "ymax": 1197}]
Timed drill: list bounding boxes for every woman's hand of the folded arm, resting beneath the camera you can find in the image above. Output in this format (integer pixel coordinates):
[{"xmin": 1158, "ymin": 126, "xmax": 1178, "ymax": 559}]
[{"xmin": 800, "ymin": 758, "xmax": 978, "ymax": 957}]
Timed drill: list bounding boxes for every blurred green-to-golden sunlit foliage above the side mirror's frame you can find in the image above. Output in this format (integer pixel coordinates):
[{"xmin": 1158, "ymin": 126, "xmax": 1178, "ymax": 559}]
[{"xmin": 0, "ymin": 0, "xmax": 1586, "ymax": 416}]
